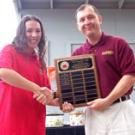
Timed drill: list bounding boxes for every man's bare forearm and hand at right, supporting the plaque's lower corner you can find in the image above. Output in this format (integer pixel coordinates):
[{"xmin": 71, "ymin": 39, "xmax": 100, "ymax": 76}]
[{"xmin": 87, "ymin": 75, "xmax": 135, "ymax": 110}]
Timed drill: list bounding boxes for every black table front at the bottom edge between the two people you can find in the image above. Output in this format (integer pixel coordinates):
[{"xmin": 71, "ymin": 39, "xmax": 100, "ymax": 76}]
[{"xmin": 46, "ymin": 126, "xmax": 85, "ymax": 135}]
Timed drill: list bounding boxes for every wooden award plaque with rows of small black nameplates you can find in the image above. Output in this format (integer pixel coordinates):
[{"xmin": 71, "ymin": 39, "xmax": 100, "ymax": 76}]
[{"xmin": 55, "ymin": 55, "xmax": 100, "ymax": 107}]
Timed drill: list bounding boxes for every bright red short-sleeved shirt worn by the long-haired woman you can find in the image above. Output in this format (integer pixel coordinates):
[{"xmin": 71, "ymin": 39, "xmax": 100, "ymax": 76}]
[{"xmin": 0, "ymin": 45, "xmax": 50, "ymax": 135}]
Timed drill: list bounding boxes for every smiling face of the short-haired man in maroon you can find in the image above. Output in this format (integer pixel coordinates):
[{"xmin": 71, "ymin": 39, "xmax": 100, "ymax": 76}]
[{"xmin": 76, "ymin": 7, "xmax": 102, "ymax": 38}]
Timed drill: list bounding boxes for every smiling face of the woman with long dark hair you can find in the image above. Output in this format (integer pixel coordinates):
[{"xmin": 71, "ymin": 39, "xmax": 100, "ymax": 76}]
[{"xmin": 25, "ymin": 20, "xmax": 42, "ymax": 50}]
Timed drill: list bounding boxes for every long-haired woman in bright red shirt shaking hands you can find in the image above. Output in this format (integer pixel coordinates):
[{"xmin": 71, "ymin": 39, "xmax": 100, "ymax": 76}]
[{"xmin": 0, "ymin": 15, "xmax": 58, "ymax": 135}]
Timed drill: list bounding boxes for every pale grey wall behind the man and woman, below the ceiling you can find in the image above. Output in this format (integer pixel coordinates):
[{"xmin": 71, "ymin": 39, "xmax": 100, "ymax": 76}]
[{"xmin": 22, "ymin": 10, "xmax": 135, "ymax": 64}]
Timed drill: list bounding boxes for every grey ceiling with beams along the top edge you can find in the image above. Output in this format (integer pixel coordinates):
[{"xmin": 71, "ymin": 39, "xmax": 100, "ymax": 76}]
[{"xmin": 14, "ymin": 0, "xmax": 135, "ymax": 10}]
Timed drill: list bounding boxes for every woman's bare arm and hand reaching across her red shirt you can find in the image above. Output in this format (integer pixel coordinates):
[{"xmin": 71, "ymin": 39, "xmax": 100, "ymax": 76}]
[{"xmin": 0, "ymin": 68, "xmax": 53, "ymax": 104}]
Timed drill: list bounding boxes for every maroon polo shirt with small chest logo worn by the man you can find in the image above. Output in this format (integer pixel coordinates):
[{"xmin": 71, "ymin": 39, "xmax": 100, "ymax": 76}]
[{"xmin": 72, "ymin": 33, "xmax": 135, "ymax": 97}]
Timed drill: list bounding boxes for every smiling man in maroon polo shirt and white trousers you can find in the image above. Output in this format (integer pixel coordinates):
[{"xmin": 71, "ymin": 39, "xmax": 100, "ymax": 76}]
[{"xmin": 63, "ymin": 4, "xmax": 135, "ymax": 135}]
